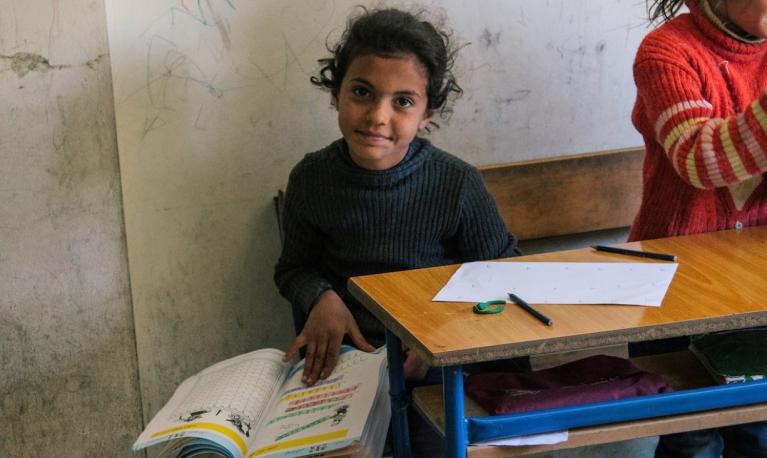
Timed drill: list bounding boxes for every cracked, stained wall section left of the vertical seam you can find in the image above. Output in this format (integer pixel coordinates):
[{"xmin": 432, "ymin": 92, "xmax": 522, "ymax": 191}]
[{"xmin": 0, "ymin": 0, "xmax": 142, "ymax": 457}]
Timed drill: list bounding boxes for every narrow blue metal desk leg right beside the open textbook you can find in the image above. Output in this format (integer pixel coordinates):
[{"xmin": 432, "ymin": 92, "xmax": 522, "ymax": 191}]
[{"xmin": 386, "ymin": 330, "xmax": 410, "ymax": 458}]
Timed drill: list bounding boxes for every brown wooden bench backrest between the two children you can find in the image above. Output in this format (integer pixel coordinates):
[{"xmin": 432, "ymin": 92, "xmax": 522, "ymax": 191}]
[{"xmin": 479, "ymin": 148, "xmax": 644, "ymax": 240}]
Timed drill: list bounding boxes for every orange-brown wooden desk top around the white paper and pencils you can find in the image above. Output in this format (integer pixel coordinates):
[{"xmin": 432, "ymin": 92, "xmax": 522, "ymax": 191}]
[{"xmin": 349, "ymin": 227, "xmax": 767, "ymax": 366}]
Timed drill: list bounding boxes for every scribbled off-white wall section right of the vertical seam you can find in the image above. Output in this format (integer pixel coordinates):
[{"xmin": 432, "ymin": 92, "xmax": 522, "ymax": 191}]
[{"xmin": 106, "ymin": 0, "xmax": 646, "ymax": 422}]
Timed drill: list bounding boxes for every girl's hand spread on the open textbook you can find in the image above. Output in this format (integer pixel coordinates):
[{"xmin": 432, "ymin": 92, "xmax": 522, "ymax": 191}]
[{"xmin": 283, "ymin": 289, "xmax": 375, "ymax": 385}]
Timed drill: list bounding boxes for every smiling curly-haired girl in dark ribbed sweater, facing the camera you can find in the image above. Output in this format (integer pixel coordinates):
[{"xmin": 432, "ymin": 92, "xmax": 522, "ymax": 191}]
[{"xmin": 275, "ymin": 9, "xmax": 517, "ymax": 385}]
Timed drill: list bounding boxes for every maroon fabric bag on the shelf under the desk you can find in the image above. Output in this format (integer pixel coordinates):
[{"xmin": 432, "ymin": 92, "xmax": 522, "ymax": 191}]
[{"xmin": 464, "ymin": 355, "xmax": 673, "ymax": 415}]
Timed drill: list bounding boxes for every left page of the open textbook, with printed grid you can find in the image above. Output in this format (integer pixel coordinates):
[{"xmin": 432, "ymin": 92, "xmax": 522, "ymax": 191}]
[{"xmin": 133, "ymin": 348, "xmax": 291, "ymax": 457}]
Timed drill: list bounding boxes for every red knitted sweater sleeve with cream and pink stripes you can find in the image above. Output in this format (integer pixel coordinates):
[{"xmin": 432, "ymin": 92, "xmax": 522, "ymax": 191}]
[{"xmin": 634, "ymin": 49, "xmax": 767, "ymax": 189}]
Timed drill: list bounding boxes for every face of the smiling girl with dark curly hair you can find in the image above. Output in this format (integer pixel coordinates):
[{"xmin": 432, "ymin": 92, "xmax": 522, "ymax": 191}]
[{"xmin": 337, "ymin": 54, "xmax": 433, "ymax": 170}]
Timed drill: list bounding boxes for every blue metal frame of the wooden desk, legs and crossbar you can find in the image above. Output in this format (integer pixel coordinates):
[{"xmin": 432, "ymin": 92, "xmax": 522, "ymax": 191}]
[{"xmin": 386, "ymin": 330, "xmax": 767, "ymax": 458}]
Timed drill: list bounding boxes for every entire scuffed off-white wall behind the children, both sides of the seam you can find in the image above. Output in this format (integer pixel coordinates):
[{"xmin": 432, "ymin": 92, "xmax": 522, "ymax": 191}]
[{"xmin": 0, "ymin": 0, "xmax": 647, "ymax": 457}]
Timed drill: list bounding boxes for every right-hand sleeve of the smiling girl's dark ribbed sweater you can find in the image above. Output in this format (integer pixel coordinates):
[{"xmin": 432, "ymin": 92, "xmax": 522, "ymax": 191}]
[{"xmin": 456, "ymin": 168, "xmax": 520, "ymax": 261}]
